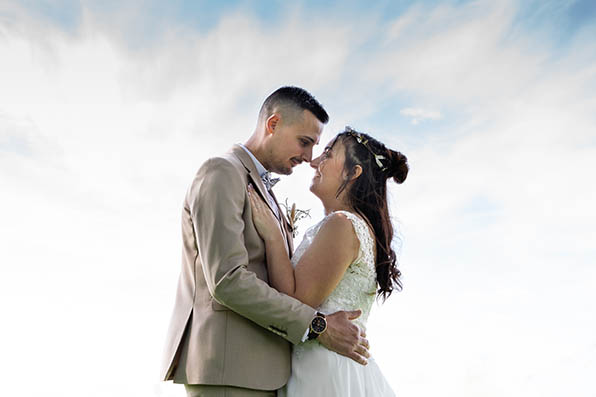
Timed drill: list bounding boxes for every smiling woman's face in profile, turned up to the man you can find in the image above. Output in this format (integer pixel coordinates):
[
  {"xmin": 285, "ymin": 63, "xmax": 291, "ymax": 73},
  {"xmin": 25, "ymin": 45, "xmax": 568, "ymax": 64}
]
[{"xmin": 310, "ymin": 140, "xmax": 346, "ymax": 199}]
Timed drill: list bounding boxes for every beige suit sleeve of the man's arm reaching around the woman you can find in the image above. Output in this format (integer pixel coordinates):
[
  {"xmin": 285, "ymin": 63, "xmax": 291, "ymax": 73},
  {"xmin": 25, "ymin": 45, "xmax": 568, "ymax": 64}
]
[{"xmin": 187, "ymin": 158, "xmax": 315, "ymax": 344}]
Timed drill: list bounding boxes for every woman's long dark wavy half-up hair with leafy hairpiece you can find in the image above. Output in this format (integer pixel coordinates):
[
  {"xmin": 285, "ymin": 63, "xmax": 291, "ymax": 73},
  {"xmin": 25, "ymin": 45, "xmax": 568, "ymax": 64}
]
[{"xmin": 331, "ymin": 127, "xmax": 409, "ymax": 300}]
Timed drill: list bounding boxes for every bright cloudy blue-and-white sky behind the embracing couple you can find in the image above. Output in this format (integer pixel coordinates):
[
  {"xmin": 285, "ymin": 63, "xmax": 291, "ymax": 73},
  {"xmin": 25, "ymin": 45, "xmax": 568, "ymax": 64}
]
[{"xmin": 0, "ymin": 0, "xmax": 596, "ymax": 397}]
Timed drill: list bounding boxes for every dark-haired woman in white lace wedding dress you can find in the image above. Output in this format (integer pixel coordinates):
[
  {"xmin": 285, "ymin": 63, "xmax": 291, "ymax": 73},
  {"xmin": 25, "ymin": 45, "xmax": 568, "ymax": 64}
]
[{"xmin": 249, "ymin": 127, "xmax": 409, "ymax": 397}]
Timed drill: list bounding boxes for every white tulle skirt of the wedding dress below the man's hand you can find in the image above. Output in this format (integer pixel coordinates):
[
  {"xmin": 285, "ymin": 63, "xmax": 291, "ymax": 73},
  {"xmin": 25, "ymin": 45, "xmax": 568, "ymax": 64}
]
[{"xmin": 278, "ymin": 341, "xmax": 395, "ymax": 397}]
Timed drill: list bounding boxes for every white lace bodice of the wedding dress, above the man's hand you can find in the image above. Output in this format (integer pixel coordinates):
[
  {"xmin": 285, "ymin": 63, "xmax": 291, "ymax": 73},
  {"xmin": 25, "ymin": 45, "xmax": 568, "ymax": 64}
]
[{"xmin": 292, "ymin": 211, "xmax": 377, "ymax": 327}]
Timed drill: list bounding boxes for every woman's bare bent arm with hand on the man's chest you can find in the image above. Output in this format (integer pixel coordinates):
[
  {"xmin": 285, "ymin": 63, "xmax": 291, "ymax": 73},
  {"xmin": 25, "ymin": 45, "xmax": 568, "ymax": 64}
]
[{"xmin": 250, "ymin": 184, "xmax": 360, "ymax": 307}]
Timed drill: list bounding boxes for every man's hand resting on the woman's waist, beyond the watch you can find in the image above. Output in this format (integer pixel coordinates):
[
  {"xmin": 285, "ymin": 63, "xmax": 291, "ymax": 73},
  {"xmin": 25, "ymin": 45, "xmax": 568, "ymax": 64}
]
[{"xmin": 317, "ymin": 310, "xmax": 370, "ymax": 365}]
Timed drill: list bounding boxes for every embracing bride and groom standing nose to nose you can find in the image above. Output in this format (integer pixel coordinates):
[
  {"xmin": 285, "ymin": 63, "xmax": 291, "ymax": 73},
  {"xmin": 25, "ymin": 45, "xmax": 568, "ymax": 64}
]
[{"xmin": 162, "ymin": 87, "xmax": 408, "ymax": 397}]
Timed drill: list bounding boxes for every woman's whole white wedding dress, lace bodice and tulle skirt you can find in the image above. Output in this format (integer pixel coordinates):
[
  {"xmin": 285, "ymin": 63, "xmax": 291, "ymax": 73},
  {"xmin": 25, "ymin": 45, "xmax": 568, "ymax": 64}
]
[{"xmin": 278, "ymin": 211, "xmax": 395, "ymax": 397}]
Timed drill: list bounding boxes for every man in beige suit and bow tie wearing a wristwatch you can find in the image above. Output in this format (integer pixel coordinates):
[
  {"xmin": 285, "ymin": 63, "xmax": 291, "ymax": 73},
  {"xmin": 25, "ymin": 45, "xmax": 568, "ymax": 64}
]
[{"xmin": 162, "ymin": 87, "xmax": 369, "ymax": 396}]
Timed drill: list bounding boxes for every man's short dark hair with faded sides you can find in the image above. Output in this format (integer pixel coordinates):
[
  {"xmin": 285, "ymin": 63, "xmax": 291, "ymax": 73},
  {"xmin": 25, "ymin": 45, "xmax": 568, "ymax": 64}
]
[{"xmin": 259, "ymin": 86, "xmax": 329, "ymax": 124}]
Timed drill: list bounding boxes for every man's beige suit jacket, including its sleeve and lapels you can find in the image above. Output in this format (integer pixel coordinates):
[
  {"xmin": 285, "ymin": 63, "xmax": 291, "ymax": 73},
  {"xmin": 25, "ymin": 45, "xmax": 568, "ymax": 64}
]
[{"xmin": 162, "ymin": 145, "xmax": 315, "ymax": 390}]
